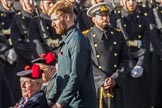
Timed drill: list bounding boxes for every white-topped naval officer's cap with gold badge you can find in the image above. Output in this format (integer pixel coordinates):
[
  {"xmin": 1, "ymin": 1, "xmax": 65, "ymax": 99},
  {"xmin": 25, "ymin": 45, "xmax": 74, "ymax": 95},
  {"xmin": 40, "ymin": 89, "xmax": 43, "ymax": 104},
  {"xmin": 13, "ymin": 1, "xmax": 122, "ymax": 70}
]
[{"xmin": 87, "ymin": 2, "xmax": 111, "ymax": 17}]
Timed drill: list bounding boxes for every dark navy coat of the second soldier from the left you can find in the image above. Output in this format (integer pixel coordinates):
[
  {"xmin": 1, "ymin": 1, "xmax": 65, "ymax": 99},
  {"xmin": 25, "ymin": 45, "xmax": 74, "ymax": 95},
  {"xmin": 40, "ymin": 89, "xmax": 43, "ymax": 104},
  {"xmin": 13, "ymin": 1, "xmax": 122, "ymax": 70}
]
[{"xmin": 11, "ymin": 10, "xmax": 34, "ymax": 102}]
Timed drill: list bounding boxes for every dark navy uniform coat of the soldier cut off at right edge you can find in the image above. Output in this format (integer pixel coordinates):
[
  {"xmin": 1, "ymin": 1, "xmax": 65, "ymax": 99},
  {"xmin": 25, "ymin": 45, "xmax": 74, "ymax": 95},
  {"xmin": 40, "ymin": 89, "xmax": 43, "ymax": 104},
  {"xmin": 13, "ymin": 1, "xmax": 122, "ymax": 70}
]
[{"xmin": 149, "ymin": 6, "xmax": 162, "ymax": 107}]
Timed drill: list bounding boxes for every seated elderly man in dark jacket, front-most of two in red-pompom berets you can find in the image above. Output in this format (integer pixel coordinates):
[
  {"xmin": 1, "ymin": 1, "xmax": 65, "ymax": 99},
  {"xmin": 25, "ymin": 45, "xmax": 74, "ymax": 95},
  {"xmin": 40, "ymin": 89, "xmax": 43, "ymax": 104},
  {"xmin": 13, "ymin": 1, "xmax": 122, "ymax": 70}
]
[{"xmin": 16, "ymin": 64, "xmax": 49, "ymax": 108}]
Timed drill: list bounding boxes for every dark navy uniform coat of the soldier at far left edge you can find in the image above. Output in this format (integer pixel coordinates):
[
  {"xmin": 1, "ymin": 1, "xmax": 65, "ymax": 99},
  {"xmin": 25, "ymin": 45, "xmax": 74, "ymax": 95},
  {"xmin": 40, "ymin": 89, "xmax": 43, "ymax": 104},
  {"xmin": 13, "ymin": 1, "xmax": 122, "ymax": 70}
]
[{"xmin": 0, "ymin": 6, "xmax": 15, "ymax": 108}]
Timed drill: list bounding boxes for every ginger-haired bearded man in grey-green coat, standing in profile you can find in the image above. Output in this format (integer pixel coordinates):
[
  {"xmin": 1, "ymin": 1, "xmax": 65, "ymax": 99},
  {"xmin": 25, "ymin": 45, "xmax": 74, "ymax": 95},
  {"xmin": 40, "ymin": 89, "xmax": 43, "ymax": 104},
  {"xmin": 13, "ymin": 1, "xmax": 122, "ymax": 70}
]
[{"xmin": 49, "ymin": 1, "xmax": 97, "ymax": 108}]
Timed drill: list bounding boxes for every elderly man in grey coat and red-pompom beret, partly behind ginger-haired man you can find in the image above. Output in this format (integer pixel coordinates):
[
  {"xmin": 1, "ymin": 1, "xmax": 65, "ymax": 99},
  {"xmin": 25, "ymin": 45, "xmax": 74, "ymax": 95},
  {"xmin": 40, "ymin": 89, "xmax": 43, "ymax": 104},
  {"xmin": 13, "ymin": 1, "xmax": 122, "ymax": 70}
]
[{"xmin": 32, "ymin": 52, "xmax": 57, "ymax": 98}]
